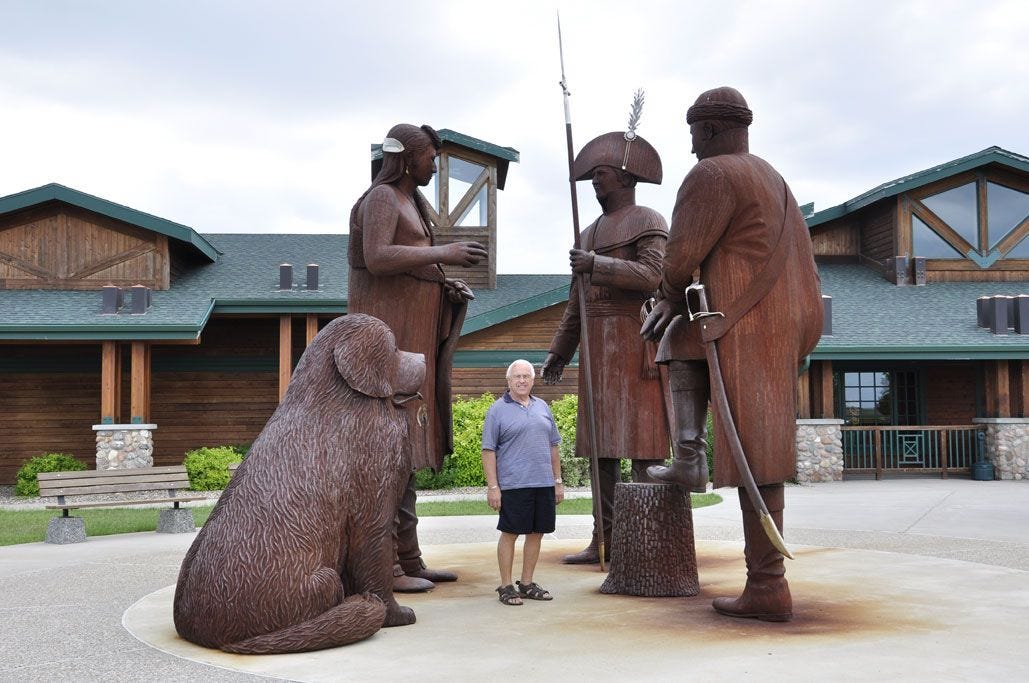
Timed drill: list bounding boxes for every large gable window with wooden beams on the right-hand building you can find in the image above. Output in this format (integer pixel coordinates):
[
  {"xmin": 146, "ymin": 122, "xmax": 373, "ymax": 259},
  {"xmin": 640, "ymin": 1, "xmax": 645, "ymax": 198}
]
[{"xmin": 907, "ymin": 171, "xmax": 1029, "ymax": 268}]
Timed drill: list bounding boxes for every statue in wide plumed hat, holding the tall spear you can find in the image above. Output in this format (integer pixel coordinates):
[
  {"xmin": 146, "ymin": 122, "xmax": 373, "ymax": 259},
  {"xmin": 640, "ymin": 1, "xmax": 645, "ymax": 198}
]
[{"xmin": 543, "ymin": 132, "xmax": 669, "ymax": 565}]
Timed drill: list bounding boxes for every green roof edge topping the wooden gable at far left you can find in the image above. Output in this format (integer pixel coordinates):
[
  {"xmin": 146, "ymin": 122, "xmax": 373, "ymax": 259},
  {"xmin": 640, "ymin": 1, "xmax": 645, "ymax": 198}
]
[{"xmin": 0, "ymin": 183, "xmax": 218, "ymax": 261}]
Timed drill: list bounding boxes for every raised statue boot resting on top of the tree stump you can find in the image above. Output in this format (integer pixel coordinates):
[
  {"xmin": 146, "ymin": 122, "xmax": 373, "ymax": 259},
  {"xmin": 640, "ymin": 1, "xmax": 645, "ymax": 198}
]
[{"xmin": 647, "ymin": 361, "xmax": 709, "ymax": 494}]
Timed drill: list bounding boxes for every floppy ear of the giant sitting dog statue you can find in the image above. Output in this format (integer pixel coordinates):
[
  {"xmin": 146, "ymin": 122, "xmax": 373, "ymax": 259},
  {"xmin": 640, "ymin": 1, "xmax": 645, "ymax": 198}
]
[{"xmin": 332, "ymin": 313, "xmax": 397, "ymax": 398}]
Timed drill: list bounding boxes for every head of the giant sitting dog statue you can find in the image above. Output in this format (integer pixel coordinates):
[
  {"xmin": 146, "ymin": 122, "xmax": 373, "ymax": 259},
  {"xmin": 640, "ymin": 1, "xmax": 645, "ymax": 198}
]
[{"xmin": 332, "ymin": 313, "xmax": 425, "ymax": 398}]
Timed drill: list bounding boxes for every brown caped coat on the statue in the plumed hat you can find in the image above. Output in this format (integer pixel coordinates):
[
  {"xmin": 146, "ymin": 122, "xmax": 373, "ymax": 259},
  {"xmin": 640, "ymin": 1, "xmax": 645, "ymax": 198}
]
[{"xmin": 551, "ymin": 206, "xmax": 669, "ymax": 460}]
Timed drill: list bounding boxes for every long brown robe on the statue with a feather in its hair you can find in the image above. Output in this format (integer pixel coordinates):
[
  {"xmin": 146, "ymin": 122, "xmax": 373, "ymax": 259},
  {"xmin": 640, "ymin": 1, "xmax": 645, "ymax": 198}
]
[{"xmin": 347, "ymin": 189, "xmax": 467, "ymax": 470}]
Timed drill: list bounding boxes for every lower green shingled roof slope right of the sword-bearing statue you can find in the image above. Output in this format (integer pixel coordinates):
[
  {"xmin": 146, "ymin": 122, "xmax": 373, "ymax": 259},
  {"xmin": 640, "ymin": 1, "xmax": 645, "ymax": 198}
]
[{"xmin": 813, "ymin": 264, "xmax": 1029, "ymax": 360}]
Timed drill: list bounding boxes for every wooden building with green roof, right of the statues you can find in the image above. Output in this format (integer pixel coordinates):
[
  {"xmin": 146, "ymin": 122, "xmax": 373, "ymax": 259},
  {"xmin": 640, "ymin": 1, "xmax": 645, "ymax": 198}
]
[{"xmin": 799, "ymin": 147, "xmax": 1029, "ymax": 478}]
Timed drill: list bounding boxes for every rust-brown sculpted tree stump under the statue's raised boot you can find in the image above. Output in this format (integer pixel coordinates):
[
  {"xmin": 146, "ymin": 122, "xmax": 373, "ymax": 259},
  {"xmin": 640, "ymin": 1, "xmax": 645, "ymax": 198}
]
[{"xmin": 600, "ymin": 483, "xmax": 700, "ymax": 598}]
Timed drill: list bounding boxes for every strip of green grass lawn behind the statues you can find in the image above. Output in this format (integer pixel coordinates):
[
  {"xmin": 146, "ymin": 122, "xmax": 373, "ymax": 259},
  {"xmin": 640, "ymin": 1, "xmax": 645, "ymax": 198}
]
[{"xmin": 0, "ymin": 494, "xmax": 721, "ymax": 545}]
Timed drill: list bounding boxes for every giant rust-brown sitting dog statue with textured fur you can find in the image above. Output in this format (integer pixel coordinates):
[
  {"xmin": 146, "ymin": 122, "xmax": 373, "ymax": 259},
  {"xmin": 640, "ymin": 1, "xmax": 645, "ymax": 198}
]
[{"xmin": 174, "ymin": 314, "xmax": 425, "ymax": 654}]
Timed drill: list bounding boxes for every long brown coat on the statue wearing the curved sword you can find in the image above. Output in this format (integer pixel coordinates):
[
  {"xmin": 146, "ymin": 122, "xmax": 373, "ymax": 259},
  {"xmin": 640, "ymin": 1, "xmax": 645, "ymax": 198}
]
[{"xmin": 658, "ymin": 154, "xmax": 822, "ymax": 487}]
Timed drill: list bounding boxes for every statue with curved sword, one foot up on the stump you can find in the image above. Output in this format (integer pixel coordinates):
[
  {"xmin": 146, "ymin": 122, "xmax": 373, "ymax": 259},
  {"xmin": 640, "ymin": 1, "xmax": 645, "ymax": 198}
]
[{"xmin": 642, "ymin": 87, "xmax": 822, "ymax": 621}]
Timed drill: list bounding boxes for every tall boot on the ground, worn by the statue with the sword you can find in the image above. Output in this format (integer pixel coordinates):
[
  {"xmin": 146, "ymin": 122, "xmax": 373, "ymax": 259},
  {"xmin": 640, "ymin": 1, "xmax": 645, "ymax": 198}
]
[{"xmin": 712, "ymin": 483, "xmax": 793, "ymax": 621}]
